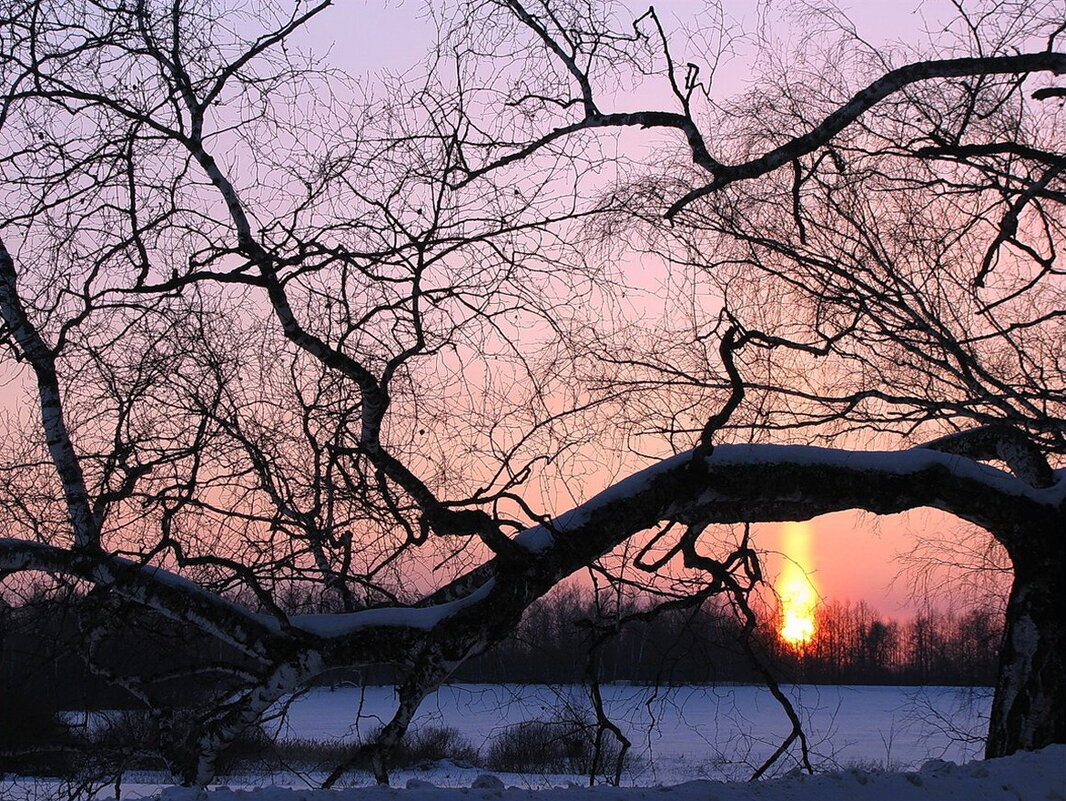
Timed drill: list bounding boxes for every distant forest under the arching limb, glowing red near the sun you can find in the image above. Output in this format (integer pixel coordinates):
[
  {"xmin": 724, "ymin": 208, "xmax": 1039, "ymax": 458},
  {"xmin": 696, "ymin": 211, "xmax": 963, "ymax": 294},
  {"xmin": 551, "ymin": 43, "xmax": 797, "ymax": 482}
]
[{"xmin": 456, "ymin": 591, "xmax": 1001, "ymax": 686}]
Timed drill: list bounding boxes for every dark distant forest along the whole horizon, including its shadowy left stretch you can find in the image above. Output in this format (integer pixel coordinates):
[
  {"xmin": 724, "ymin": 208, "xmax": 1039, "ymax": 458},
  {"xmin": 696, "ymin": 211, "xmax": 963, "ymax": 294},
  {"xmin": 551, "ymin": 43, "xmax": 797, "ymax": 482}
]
[{"xmin": 0, "ymin": 589, "xmax": 1001, "ymax": 708}]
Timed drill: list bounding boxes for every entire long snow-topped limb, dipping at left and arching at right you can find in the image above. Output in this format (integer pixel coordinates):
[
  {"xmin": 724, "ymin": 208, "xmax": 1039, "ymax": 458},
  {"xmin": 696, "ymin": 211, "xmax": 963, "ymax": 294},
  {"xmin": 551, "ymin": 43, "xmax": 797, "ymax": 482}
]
[{"xmin": 0, "ymin": 445, "xmax": 1066, "ymax": 657}]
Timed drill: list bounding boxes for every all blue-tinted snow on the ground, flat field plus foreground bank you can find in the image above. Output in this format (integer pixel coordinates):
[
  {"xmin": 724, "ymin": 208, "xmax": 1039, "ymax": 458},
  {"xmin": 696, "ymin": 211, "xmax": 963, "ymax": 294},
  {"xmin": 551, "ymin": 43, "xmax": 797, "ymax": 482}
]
[{"xmin": 10, "ymin": 685, "xmax": 1066, "ymax": 801}]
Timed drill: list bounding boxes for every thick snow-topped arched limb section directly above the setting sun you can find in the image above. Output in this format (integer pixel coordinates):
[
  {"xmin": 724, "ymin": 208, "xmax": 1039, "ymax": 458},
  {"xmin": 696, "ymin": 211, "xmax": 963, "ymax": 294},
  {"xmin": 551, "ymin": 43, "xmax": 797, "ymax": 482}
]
[{"xmin": 517, "ymin": 445, "xmax": 1066, "ymax": 562}]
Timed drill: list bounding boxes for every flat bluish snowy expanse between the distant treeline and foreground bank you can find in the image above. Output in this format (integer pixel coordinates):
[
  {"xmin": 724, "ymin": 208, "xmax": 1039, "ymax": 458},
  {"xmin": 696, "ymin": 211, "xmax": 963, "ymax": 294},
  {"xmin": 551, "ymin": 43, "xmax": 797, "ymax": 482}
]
[{"xmin": 260, "ymin": 685, "xmax": 991, "ymax": 785}]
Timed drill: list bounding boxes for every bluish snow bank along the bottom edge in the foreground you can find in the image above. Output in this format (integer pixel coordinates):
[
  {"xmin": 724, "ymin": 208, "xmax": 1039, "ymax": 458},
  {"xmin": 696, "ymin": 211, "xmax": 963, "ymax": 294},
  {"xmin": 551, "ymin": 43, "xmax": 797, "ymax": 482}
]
[{"xmin": 155, "ymin": 746, "xmax": 1066, "ymax": 801}]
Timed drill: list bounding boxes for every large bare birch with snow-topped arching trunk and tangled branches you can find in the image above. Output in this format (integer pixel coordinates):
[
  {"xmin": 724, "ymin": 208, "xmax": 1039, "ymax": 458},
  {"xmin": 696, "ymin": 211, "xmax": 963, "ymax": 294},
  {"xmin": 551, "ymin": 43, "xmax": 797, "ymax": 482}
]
[{"xmin": 0, "ymin": 0, "xmax": 1066, "ymax": 785}]
